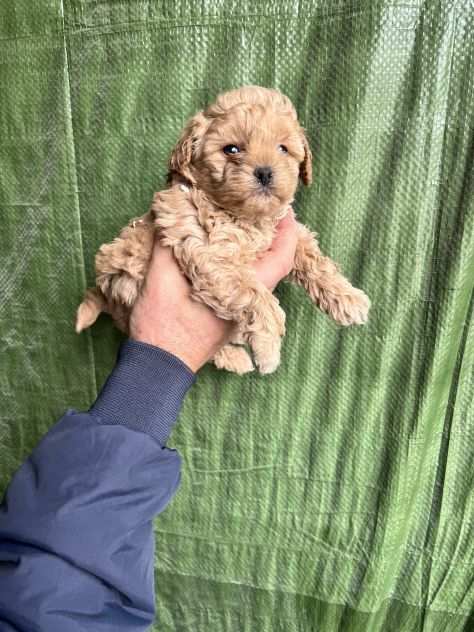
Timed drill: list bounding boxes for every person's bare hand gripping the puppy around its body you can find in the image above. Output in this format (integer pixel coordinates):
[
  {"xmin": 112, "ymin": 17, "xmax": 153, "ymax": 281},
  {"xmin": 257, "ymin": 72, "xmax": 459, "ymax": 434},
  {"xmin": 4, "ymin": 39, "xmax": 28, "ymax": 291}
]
[{"xmin": 130, "ymin": 209, "xmax": 297, "ymax": 371}]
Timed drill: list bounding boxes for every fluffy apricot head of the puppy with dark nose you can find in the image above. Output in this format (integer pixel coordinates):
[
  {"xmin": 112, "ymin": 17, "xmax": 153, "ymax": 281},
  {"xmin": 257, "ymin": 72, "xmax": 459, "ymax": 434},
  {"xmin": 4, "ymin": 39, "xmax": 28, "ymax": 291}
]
[{"xmin": 168, "ymin": 86, "xmax": 311, "ymax": 216}]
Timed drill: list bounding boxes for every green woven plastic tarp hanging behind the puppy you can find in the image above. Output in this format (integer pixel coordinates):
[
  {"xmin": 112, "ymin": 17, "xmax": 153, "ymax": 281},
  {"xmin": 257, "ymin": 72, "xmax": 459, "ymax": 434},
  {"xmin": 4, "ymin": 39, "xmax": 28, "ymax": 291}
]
[{"xmin": 0, "ymin": 0, "xmax": 474, "ymax": 632}]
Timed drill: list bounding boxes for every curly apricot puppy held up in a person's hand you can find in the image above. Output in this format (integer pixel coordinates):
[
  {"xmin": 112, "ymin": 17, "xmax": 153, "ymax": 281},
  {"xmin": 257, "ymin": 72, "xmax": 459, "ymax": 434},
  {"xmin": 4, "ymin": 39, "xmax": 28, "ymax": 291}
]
[{"xmin": 76, "ymin": 86, "xmax": 370, "ymax": 374}]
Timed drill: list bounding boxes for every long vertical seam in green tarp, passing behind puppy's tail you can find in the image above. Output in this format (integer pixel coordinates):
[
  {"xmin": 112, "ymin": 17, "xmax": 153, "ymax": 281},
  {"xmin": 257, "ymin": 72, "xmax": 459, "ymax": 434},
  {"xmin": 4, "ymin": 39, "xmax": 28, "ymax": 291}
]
[{"xmin": 61, "ymin": 0, "xmax": 98, "ymax": 399}]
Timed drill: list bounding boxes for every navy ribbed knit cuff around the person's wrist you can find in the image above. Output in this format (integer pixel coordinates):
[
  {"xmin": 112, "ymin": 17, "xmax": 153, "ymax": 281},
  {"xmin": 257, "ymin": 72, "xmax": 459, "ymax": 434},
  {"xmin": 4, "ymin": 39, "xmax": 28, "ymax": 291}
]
[{"xmin": 88, "ymin": 338, "xmax": 196, "ymax": 445}]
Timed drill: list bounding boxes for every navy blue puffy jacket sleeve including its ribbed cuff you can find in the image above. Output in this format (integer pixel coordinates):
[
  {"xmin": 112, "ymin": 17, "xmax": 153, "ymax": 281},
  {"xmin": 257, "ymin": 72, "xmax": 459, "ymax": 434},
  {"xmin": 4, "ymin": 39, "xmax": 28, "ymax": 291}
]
[{"xmin": 0, "ymin": 340, "xmax": 195, "ymax": 632}]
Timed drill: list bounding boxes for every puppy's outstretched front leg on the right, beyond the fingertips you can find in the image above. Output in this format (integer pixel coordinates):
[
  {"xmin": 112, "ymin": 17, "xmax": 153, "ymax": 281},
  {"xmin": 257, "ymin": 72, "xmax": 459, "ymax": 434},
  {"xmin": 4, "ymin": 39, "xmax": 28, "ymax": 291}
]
[{"xmin": 289, "ymin": 224, "xmax": 370, "ymax": 325}]
